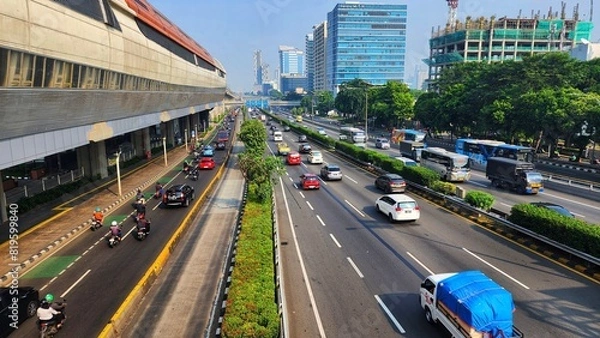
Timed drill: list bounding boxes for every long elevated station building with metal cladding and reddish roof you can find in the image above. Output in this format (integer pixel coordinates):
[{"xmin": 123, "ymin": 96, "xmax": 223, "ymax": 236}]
[{"xmin": 0, "ymin": 0, "xmax": 233, "ymax": 222}]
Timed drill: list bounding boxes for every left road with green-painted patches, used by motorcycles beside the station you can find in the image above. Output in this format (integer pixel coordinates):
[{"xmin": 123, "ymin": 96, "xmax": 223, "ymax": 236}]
[{"xmin": 11, "ymin": 133, "xmax": 232, "ymax": 337}]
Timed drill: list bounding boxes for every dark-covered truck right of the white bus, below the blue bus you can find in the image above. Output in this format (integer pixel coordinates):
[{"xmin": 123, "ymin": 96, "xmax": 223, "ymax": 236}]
[{"xmin": 485, "ymin": 157, "xmax": 544, "ymax": 194}]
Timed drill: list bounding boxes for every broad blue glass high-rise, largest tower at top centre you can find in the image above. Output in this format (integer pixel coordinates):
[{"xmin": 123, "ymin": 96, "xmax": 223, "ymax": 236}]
[{"xmin": 326, "ymin": 2, "xmax": 407, "ymax": 93}]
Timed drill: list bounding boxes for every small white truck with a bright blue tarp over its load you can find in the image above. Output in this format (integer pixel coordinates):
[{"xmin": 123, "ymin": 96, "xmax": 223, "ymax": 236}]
[{"xmin": 419, "ymin": 271, "xmax": 523, "ymax": 338}]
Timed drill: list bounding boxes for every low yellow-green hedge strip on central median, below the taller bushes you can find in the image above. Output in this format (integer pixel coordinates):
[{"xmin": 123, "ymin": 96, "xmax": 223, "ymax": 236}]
[{"xmin": 221, "ymin": 184, "xmax": 280, "ymax": 338}]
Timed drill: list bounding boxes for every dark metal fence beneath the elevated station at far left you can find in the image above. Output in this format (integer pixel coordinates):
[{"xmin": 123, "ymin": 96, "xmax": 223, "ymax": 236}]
[{"xmin": 5, "ymin": 167, "xmax": 85, "ymax": 203}]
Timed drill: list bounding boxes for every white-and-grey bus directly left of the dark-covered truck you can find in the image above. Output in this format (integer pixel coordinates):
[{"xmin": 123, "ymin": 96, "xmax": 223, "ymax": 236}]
[{"xmin": 421, "ymin": 147, "xmax": 471, "ymax": 182}]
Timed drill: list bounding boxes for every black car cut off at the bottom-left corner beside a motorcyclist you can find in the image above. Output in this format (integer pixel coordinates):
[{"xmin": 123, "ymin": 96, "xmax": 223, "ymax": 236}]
[{"xmin": 0, "ymin": 286, "xmax": 40, "ymax": 337}]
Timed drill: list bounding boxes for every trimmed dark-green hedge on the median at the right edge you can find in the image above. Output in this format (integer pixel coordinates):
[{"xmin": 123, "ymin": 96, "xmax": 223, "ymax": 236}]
[{"xmin": 508, "ymin": 204, "xmax": 600, "ymax": 257}]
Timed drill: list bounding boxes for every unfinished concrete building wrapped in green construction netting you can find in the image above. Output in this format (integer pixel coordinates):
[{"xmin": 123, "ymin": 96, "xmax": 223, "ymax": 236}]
[{"xmin": 424, "ymin": 1, "xmax": 593, "ymax": 85}]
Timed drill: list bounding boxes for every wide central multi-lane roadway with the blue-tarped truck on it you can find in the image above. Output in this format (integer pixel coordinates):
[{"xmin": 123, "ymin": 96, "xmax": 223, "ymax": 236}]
[{"xmin": 270, "ymin": 120, "xmax": 600, "ymax": 337}]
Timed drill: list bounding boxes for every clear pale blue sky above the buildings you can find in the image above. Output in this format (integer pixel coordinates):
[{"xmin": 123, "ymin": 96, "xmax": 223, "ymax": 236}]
[{"xmin": 149, "ymin": 0, "xmax": 600, "ymax": 92}]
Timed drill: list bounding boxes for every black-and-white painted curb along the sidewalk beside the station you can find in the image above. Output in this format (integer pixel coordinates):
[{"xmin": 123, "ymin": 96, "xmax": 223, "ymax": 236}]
[{"xmin": 0, "ymin": 152, "xmax": 187, "ymax": 283}]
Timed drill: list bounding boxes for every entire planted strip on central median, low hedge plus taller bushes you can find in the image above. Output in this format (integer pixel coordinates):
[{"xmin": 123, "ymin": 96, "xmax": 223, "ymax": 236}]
[{"xmin": 221, "ymin": 115, "xmax": 283, "ymax": 338}]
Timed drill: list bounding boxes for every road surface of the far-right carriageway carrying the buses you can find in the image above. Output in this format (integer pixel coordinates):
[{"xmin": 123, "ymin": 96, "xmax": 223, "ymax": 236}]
[{"xmin": 286, "ymin": 116, "xmax": 600, "ymax": 224}]
